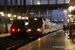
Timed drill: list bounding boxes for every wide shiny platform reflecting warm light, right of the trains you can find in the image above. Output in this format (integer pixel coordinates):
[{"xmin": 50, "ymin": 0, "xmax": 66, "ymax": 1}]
[{"xmin": 17, "ymin": 30, "xmax": 75, "ymax": 50}]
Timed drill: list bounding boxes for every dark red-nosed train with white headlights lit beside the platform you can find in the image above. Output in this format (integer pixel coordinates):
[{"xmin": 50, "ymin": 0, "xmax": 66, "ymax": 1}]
[{"xmin": 26, "ymin": 18, "xmax": 59, "ymax": 39}]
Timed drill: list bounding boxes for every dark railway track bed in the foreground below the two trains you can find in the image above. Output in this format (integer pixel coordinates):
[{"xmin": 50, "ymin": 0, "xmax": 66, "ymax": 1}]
[{"xmin": 0, "ymin": 31, "xmax": 56, "ymax": 50}]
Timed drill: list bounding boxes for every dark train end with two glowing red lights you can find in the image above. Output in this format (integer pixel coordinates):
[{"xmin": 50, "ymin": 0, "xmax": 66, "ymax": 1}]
[{"xmin": 10, "ymin": 20, "xmax": 27, "ymax": 37}]
